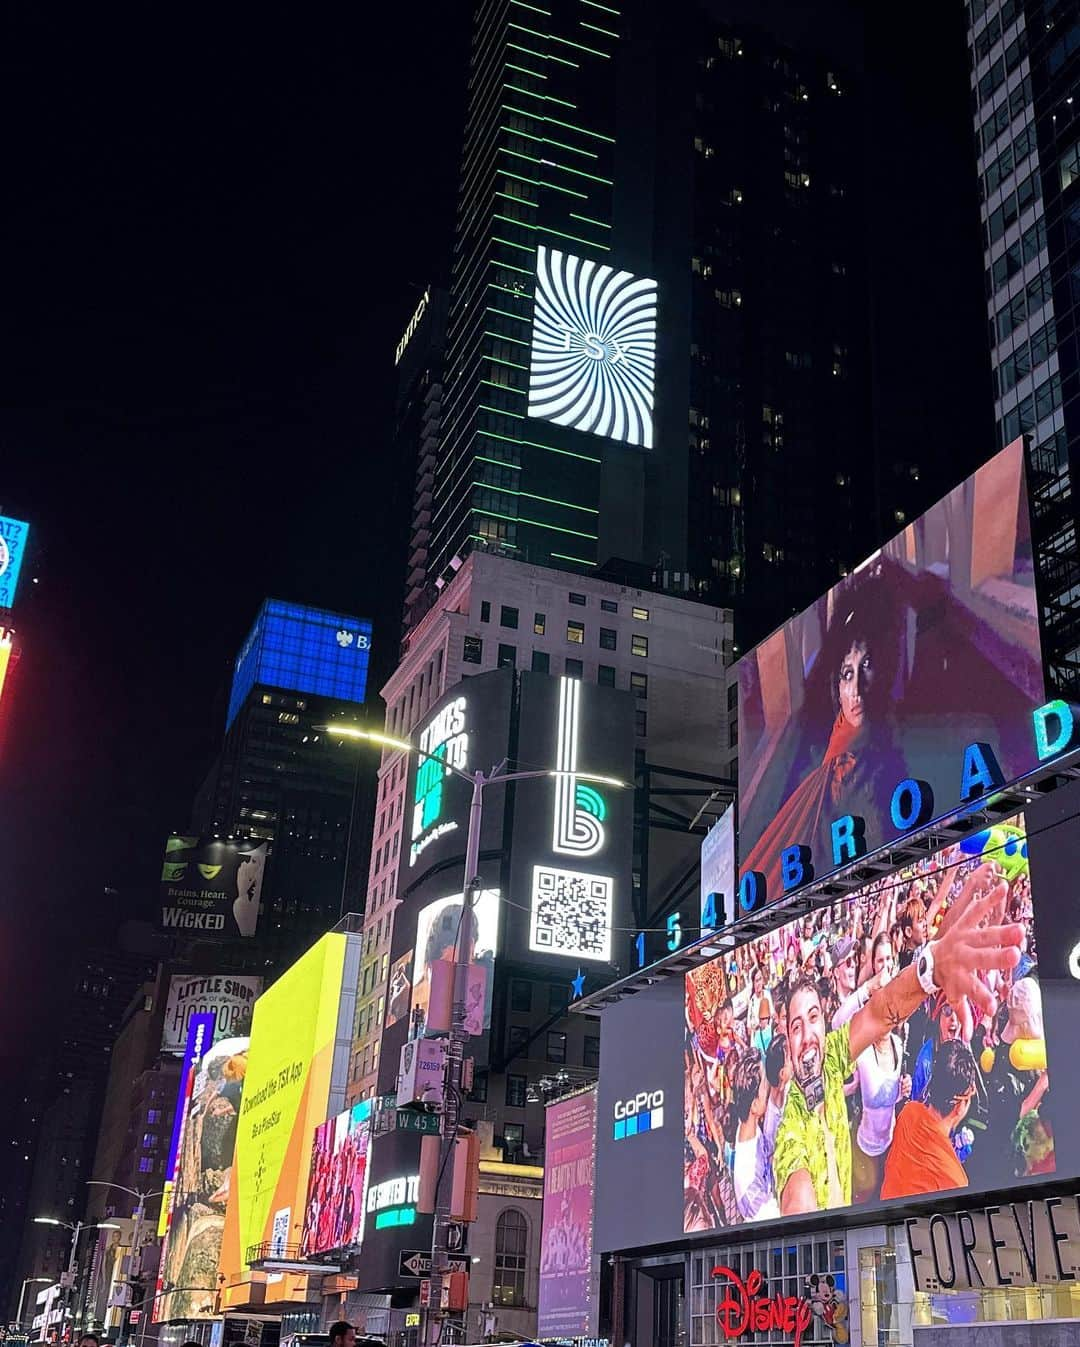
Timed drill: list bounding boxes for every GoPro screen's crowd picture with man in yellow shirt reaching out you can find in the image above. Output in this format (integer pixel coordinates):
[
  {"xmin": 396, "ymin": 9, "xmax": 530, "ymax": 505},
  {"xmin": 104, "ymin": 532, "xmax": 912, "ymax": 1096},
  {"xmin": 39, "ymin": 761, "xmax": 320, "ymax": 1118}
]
[{"xmin": 680, "ymin": 814, "xmax": 1061, "ymax": 1231}]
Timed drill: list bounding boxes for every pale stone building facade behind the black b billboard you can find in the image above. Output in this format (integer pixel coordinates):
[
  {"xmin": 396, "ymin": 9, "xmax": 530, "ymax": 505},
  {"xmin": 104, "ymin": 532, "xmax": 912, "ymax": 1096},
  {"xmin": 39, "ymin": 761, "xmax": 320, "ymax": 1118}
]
[{"xmin": 349, "ymin": 551, "xmax": 735, "ymax": 1099}]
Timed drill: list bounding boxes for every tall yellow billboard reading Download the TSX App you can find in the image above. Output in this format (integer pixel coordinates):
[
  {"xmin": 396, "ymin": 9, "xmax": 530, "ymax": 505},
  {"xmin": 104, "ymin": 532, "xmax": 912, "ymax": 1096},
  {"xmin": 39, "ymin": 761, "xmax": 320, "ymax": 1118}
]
[{"xmin": 220, "ymin": 932, "xmax": 351, "ymax": 1304}]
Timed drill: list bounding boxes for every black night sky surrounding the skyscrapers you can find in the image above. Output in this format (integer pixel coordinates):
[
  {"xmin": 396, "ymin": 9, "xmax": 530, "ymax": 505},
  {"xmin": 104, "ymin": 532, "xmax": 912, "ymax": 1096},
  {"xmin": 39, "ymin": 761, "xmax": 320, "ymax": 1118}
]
[{"xmin": 0, "ymin": 0, "xmax": 991, "ymax": 1070}]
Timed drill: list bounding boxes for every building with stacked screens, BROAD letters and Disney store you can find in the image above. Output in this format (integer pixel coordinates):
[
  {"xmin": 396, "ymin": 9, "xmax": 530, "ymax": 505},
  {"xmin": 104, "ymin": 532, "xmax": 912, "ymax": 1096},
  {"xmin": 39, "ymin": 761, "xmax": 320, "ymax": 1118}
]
[{"xmin": 570, "ymin": 443, "xmax": 1080, "ymax": 1347}]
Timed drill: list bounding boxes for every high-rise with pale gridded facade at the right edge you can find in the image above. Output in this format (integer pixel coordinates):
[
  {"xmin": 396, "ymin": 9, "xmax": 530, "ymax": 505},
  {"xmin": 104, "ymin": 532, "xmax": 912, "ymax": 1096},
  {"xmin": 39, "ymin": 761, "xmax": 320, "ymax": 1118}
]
[{"xmin": 967, "ymin": 0, "xmax": 1080, "ymax": 692}]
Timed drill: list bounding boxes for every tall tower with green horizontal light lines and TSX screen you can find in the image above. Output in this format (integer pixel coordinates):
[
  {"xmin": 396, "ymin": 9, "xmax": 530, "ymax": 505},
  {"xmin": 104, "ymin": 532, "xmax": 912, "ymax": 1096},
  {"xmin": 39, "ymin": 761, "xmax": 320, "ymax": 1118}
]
[{"xmin": 423, "ymin": 0, "xmax": 665, "ymax": 611}]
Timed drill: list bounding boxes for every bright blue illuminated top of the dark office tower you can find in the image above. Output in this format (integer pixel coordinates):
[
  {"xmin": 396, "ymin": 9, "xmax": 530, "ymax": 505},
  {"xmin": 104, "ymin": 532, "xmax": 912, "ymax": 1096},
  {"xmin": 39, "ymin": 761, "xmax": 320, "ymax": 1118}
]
[{"xmin": 225, "ymin": 598, "xmax": 372, "ymax": 730}]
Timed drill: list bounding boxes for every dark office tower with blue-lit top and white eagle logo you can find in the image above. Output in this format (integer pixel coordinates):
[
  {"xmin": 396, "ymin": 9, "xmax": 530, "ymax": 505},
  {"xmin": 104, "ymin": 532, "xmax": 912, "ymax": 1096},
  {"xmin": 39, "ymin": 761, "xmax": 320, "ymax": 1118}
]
[{"xmin": 193, "ymin": 599, "xmax": 374, "ymax": 971}]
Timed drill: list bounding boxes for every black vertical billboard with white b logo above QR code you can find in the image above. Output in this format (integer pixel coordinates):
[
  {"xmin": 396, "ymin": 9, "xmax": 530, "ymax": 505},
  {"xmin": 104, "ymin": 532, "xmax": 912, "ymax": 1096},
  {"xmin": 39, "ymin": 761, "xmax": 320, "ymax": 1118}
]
[{"xmin": 506, "ymin": 674, "xmax": 634, "ymax": 973}]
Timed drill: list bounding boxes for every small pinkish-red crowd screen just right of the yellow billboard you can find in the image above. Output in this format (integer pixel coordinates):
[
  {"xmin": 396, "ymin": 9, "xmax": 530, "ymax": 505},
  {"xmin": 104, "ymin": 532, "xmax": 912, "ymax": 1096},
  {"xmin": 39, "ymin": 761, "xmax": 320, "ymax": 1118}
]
[{"xmin": 300, "ymin": 1099, "xmax": 372, "ymax": 1257}]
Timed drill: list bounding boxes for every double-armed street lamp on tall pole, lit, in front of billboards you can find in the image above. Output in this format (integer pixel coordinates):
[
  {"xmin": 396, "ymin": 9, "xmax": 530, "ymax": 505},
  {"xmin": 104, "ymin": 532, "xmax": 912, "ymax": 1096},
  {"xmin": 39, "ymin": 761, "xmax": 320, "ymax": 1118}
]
[{"xmin": 325, "ymin": 725, "xmax": 626, "ymax": 1344}]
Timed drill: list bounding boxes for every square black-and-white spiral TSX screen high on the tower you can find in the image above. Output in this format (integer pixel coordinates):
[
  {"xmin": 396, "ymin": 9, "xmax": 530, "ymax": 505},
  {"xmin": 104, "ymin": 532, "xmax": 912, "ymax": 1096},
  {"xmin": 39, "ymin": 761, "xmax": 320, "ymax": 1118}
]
[{"xmin": 529, "ymin": 245, "xmax": 657, "ymax": 449}]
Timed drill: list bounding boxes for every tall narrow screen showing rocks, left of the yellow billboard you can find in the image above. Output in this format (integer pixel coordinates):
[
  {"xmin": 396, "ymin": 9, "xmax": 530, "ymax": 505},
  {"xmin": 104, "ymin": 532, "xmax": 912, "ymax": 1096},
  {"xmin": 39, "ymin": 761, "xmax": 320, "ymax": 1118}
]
[{"xmin": 154, "ymin": 1037, "xmax": 249, "ymax": 1321}]
